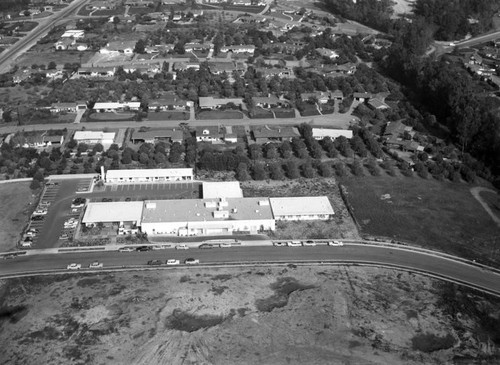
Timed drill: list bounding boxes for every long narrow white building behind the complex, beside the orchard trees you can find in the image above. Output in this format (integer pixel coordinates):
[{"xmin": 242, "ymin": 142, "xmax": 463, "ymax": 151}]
[{"xmin": 104, "ymin": 168, "xmax": 194, "ymax": 184}]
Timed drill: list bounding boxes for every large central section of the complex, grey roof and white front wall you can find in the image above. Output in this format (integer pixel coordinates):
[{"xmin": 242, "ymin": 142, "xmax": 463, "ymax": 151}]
[{"xmin": 141, "ymin": 198, "xmax": 275, "ymax": 236}]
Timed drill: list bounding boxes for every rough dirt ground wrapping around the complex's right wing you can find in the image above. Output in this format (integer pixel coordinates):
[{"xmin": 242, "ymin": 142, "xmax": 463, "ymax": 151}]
[{"xmin": 241, "ymin": 179, "xmax": 360, "ymax": 239}]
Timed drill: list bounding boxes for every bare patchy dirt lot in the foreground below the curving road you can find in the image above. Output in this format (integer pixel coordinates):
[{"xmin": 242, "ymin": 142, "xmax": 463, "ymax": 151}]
[{"xmin": 0, "ymin": 266, "xmax": 500, "ymax": 365}]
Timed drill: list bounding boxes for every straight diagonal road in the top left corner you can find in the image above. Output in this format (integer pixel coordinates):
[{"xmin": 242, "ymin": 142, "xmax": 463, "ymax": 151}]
[{"xmin": 0, "ymin": 0, "xmax": 89, "ymax": 73}]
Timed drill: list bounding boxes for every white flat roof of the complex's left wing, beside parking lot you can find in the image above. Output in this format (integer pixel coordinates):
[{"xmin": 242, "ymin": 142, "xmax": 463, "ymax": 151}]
[{"xmin": 82, "ymin": 202, "xmax": 143, "ymax": 225}]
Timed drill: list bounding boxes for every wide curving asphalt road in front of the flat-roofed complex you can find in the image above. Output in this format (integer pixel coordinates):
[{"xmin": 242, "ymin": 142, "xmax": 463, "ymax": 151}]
[{"xmin": 0, "ymin": 244, "xmax": 500, "ymax": 295}]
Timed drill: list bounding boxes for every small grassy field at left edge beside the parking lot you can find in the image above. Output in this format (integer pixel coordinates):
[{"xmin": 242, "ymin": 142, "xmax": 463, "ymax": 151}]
[{"xmin": 0, "ymin": 181, "xmax": 34, "ymax": 252}]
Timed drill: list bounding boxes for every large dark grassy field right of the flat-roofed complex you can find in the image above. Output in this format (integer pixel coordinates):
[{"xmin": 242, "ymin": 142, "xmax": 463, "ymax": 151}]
[{"xmin": 341, "ymin": 176, "xmax": 500, "ymax": 266}]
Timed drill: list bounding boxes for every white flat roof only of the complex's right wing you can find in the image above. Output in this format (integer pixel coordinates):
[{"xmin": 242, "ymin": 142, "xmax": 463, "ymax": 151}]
[{"xmin": 269, "ymin": 196, "xmax": 334, "ymax": 217}]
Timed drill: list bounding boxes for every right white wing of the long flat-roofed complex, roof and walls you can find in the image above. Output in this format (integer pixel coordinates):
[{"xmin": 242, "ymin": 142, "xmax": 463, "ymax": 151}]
[{"xmin": 269, "ymin": 196, "xmax": 334, "ymax": 221}]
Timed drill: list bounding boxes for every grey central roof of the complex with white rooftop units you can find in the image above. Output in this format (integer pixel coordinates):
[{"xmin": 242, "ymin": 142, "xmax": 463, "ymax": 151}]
[{"xmin": 142, "ymin": 198, "xmax": 273, "ymax": 223}]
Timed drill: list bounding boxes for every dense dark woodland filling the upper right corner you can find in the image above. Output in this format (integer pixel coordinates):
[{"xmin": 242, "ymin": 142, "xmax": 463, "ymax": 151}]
[{"xmin": 325, "ymin": 0, "xmax": 500, "ymax": 175}]
